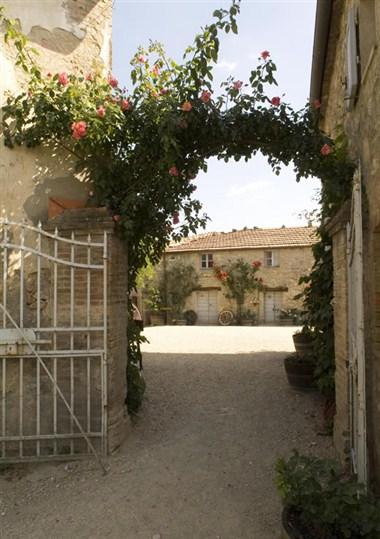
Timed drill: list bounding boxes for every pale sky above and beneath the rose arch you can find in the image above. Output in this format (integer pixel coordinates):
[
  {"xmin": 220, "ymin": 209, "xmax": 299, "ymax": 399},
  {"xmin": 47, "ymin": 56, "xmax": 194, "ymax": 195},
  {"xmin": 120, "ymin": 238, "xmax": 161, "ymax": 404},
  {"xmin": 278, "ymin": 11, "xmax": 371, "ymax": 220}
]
[{"xmin": 113, "ymin": 0, "xmax": 319, "ymax": 231}]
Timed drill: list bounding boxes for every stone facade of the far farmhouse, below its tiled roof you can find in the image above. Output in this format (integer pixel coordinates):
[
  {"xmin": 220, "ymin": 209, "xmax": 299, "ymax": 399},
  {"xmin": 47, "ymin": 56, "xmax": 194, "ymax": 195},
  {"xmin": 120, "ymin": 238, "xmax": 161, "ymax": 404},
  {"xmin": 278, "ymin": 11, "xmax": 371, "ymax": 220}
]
[{"xmin": 161, "ymin": 247, "xmax": 313, "ymax": 321}]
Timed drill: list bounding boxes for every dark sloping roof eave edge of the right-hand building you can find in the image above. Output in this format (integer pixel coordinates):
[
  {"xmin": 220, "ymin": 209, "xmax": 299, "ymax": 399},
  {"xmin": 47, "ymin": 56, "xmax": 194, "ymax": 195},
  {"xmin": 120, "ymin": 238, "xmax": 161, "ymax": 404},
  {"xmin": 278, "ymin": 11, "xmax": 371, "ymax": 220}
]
[{"xmin": 310, "ymin": 0, "xmax": 332, "ymax": 103}]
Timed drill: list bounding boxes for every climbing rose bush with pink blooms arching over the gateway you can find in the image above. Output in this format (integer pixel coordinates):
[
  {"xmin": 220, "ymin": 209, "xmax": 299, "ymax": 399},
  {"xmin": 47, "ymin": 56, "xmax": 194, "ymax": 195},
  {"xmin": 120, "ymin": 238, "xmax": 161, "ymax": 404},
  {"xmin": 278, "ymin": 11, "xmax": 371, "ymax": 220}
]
[{"xmin": 0, "ymin": 0, "xmax": 353, "ymax": 404}]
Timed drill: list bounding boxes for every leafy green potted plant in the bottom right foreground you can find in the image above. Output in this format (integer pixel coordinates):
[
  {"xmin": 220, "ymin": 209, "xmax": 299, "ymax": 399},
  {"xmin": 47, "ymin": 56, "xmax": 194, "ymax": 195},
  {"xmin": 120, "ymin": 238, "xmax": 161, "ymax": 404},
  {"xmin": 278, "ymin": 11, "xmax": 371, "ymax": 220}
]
[{"xmin": 275, "ymin": 451, "xmax": 380, "ymax": 539}]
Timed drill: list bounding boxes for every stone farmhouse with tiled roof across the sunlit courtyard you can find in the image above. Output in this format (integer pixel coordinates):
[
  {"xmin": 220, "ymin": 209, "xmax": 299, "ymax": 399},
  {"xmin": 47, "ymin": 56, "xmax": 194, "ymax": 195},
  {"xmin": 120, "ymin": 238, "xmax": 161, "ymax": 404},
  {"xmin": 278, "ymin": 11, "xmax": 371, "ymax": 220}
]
[{"xmin": 161, "ymin": 227, "xmax": 317, "ymax": 324}]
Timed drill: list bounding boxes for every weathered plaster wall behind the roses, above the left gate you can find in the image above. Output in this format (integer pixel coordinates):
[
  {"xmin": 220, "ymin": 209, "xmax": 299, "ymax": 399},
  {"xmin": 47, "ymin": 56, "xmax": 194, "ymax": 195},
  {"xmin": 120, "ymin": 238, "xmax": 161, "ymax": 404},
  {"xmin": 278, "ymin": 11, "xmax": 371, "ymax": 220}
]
[{"xmin": 0, "ymin": 0, "xmax": 112, "ymax": 222}]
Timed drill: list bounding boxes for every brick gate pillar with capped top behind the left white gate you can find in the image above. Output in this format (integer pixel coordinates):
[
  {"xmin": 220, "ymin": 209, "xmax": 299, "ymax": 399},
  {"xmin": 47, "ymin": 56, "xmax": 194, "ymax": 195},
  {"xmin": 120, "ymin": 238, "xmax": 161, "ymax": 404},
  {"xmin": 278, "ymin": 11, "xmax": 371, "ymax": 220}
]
[{"xmin": 45, "ymin": 208, "xmax": 128, "ymax": 453}]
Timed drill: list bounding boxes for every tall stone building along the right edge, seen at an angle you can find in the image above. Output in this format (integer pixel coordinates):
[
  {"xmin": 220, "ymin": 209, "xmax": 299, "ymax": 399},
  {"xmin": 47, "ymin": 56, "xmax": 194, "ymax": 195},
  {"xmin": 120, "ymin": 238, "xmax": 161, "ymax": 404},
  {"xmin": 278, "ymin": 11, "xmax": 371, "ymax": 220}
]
[{"xmin": 310, "ymin": 0, "xmax": 380, "ymax": 487}]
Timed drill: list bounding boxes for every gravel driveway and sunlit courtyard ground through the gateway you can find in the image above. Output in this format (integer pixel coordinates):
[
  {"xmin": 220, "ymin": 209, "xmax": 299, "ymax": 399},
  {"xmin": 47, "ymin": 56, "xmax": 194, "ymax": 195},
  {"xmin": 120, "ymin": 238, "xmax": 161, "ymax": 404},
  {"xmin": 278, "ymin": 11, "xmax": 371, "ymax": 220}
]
[{"xmin": 0, "ymin": 326, "xmax": 332, "ymax": 539}]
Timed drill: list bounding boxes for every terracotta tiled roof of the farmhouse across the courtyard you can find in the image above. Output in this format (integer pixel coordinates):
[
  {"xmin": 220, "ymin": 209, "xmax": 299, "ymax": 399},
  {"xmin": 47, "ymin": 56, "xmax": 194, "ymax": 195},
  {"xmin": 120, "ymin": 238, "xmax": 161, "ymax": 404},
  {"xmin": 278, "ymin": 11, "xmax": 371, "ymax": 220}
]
[{"xmin": 166, "ymin": 227, "xmax": 317, "ymax": 252}]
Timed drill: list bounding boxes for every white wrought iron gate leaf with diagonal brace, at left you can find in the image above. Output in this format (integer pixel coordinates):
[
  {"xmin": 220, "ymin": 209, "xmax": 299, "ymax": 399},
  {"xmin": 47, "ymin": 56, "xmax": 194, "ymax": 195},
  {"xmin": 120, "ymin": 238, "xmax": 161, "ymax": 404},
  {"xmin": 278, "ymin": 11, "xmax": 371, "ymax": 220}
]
[{"xmin": 0, "ymin": 219, "xmax": 107, "ymax": 462}]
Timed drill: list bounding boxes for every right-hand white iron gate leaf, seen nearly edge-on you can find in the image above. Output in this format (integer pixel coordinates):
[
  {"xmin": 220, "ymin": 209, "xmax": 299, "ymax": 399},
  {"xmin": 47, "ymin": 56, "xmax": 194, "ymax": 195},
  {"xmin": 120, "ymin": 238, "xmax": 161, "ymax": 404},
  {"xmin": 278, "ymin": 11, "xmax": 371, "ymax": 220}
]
[{"xmin": 347, "ymin": 170, "xmax": 367, "ymax": 484}]
